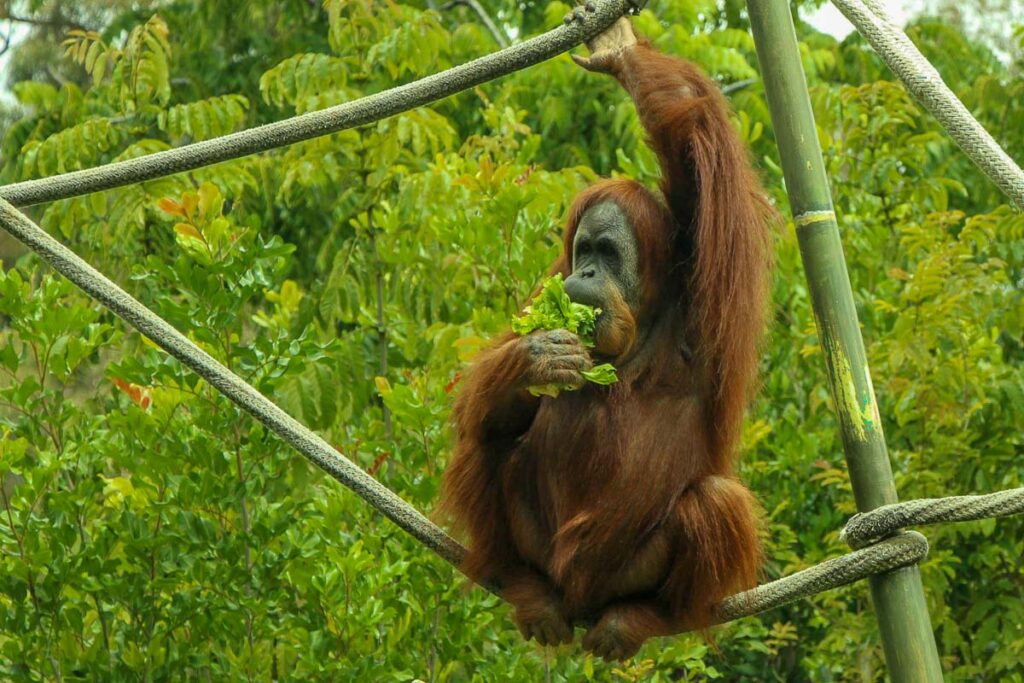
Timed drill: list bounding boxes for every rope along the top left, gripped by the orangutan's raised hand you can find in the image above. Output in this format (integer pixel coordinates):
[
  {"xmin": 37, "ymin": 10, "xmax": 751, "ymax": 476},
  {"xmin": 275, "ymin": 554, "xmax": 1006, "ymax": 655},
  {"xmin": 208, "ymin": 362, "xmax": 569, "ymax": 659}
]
[{"xmin": 0, "ymin": 0, "xmax": 634, "ymax": 206}]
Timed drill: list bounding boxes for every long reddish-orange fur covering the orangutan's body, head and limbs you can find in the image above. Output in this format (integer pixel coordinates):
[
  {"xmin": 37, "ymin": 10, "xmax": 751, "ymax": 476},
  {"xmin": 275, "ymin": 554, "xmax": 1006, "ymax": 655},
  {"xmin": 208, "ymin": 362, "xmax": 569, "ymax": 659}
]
[{"xmin": 442, "ymin": 38, "xmax": 771, "ymax": 657}]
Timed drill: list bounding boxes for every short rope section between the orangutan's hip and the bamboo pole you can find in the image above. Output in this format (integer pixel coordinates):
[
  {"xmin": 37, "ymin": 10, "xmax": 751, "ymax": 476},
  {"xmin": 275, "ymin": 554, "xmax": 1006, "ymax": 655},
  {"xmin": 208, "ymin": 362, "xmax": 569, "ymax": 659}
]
[{"xmin": 716, "ymin": 531, "xmax": 928, "ymax": 624}]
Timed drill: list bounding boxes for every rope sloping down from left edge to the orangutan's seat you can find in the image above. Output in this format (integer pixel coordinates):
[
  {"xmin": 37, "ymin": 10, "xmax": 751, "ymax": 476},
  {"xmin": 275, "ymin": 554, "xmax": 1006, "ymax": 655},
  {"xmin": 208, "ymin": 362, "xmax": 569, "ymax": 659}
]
[{"xmin": 0, "ymin": 200, "xmax": 466, "ymax": 565}]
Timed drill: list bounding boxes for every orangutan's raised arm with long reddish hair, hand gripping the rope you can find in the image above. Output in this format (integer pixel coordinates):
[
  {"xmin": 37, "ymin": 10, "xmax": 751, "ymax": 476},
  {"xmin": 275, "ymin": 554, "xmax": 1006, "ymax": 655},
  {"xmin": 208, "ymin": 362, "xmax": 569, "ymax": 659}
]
[{"xmin": 573, "ymin": 18, "xmax": 774, "ymax": 458}]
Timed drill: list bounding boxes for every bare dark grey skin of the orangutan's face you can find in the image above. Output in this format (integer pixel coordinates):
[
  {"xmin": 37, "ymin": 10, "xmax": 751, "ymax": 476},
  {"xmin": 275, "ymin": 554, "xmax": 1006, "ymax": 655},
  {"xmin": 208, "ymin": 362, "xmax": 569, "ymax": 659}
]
[{"xmin": 565, "ymin": 202, "xmax": 641, "ymax": 311}]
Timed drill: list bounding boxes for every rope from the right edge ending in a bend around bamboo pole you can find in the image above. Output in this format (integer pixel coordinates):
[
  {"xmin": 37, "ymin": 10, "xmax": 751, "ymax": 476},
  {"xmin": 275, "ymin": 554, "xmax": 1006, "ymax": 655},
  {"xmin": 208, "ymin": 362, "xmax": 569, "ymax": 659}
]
[{"xmin": 840, "ymin": 488, "xmax": 1024, "ymax": 548}]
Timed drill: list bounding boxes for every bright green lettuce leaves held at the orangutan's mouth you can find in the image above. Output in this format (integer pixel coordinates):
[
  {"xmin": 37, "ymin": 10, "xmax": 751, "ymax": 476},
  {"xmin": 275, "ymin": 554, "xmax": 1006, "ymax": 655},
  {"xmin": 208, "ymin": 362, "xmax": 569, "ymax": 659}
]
[{"xmin": 512, "ymin": 273, "xmax": 618, "ymax": 397}]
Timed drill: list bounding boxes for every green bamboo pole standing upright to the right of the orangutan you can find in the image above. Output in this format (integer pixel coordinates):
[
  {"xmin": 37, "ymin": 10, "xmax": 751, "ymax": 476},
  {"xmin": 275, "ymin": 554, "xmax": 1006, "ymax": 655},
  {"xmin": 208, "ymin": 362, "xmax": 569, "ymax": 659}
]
[{"xmin": 746, "ymin": 0, "xmax": 942, "ymax": 683}]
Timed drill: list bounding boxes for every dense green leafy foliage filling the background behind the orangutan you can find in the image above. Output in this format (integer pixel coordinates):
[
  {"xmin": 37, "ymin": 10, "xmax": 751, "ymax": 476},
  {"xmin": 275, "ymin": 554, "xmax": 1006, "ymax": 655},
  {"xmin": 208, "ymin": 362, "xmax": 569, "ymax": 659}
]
[{"xmin": 0, "ymin": 0, "xmax": 1024, "ymax": 682}]
